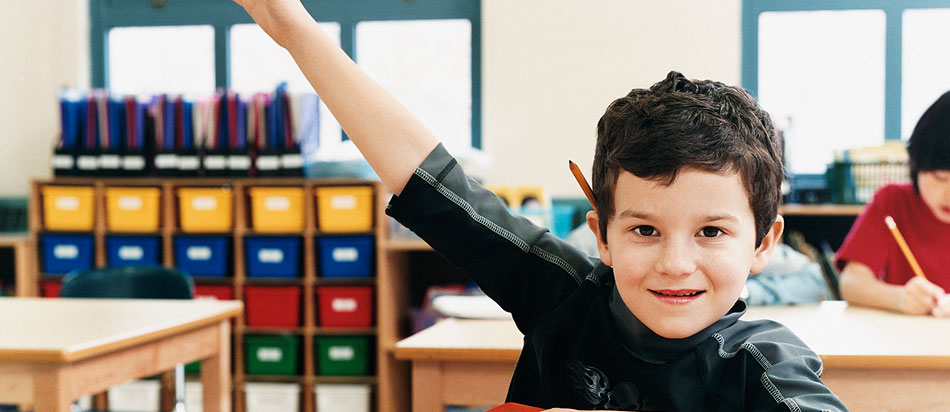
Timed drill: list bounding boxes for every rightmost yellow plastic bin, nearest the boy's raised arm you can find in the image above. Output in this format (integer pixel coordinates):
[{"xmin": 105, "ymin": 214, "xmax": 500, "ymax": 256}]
[{"xmin": 316, "ymin": 186, "xmax": 373, "ymax": 232}]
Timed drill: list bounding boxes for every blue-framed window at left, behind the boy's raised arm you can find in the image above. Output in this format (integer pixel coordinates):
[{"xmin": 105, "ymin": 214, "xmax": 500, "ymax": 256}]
[{"xmin": 89, "ymin": 0, "xmax": 481, "ymax": 152}]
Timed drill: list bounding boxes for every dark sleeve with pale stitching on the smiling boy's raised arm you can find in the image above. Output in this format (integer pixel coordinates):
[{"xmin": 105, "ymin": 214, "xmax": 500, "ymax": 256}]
[{"xmin": 386, "ymin": 144, "xmax": 594, "ymax": 334}]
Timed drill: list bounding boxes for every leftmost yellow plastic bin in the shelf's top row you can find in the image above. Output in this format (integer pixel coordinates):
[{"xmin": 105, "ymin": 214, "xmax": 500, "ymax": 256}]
[{"xmin": 42, "ymin": 186, "xmax": 95, "ymax": 231}]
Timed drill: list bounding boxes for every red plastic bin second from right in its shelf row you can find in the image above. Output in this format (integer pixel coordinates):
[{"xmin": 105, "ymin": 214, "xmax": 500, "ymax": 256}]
[{"xmin": 244, "ymin": 286, "xmax": 300, "ymax": 328}]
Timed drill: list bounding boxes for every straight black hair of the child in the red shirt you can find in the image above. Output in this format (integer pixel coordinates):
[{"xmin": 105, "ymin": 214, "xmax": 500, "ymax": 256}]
[{"xmin": 907, "ymin": 92, "xmax": 950, "ymax": 193}]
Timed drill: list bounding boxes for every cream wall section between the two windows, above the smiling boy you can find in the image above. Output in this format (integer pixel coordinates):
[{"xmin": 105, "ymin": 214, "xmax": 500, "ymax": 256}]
[{"xmin": 482, "ymin": 0, "xmax": 741, "ymax": 197}]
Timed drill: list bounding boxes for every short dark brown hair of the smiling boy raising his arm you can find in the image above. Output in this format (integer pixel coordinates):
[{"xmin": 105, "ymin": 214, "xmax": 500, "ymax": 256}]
[{"xmin": 592, "ymin": 71, "xmax": 784, "ymax": 247}]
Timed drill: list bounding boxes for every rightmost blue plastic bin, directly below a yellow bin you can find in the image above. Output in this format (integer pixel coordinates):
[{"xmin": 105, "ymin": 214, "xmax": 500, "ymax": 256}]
[{"xmin": 317, "ymin": 236, "xmax": 373, "ymax": 278}]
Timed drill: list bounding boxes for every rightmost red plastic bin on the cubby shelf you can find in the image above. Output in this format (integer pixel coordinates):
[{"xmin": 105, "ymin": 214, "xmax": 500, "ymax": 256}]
[{"xmin": 317, "ymin": 286, "xmax": 373, "ymax": 328}]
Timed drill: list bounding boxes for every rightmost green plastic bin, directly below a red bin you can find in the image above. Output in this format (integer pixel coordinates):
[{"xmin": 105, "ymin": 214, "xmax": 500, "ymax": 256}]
[{"xmin": 316, "ymin": 336, "xmax": 369, "ymax": 376}]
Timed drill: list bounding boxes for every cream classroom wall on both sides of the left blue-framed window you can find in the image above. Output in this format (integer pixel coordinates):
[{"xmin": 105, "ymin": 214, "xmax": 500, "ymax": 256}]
[{"xmin": 0, "ymin": 0, "xmax": 741, "ymax": 197}]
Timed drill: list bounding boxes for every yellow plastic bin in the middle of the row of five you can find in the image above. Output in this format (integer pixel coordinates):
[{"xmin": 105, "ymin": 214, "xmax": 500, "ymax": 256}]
[{"xmin": 178, "ymin": 187, "xmax": 233, "ymax": 233}]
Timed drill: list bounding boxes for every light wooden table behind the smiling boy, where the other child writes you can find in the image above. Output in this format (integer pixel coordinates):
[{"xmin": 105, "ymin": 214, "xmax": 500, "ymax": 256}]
[{"xmin": 395, "ymin": 302, "xmax": 950, "ymax": 412}]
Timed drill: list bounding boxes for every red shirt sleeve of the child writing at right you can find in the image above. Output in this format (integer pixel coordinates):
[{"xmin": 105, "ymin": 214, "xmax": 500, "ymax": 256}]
[{"xmin": 835, "ymin": 187, "xmax": 894, "ymax": 278}]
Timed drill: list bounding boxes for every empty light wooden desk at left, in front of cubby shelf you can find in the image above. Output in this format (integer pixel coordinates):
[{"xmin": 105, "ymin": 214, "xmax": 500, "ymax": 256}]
[{"xmin": 0, "ymin": 298, "xmax": 243, "ymax": 412}]
